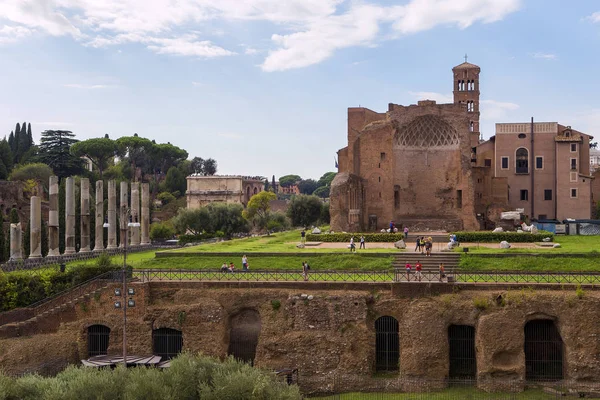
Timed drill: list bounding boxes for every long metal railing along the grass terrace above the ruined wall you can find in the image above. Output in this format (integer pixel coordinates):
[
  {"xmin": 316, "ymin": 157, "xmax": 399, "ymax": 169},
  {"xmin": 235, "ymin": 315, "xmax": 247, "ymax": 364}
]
[{"xmin": 133, "ymin": 268, "xmax": 600, "ymax": 285}]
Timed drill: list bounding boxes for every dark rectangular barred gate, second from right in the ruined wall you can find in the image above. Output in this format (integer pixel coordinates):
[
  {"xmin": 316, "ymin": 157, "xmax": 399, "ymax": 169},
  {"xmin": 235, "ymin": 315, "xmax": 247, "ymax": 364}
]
[{"xmin": 448, "ymin": 325, "xmax": 477, "ymax": 379}]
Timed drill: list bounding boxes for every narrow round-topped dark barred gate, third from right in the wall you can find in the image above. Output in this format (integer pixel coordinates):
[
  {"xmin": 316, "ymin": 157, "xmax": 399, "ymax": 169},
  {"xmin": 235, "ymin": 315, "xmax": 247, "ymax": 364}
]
[{"xmin": 375, "ymin": 316, "xmax": 400, "ymax": 371}]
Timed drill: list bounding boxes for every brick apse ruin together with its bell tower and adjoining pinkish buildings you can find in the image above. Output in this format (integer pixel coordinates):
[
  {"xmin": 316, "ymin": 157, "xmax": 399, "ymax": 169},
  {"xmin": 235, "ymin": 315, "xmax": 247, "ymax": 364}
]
[{"xmin": 330, "ymin": 62, "xmax": 593, "ymax": 232}]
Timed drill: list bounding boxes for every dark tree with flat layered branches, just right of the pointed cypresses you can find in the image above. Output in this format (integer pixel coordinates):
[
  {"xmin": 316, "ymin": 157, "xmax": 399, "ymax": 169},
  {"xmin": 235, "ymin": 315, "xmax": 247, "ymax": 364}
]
[{"xmin": 37, "ymin": 131, "xmax": 83, "ymax": 178}]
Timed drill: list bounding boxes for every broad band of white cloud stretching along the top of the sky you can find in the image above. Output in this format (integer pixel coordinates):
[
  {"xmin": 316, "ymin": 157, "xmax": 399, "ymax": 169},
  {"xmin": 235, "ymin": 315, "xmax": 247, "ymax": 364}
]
[{"xmin": 0, "ymin": 0, "xmax": 521, "ymax": 71}]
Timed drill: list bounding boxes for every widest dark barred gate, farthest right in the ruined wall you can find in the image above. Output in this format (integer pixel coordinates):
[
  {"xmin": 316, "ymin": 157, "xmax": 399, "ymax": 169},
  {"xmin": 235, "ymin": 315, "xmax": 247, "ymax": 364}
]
[{"xmin": 525, "ymin": 319, "xmax": 563, "ymax": 381}]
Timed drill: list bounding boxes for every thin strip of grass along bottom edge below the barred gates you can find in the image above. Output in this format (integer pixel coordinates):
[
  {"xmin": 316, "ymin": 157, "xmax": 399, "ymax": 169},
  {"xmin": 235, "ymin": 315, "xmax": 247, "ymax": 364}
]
[{"xmin": 312, "ymin": 388, "xmax": 556, "ymax": 400}]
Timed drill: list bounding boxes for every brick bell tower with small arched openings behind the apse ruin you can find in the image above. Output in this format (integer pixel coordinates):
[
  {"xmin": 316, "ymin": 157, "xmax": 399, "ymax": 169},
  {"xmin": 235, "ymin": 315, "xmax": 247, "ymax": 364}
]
[{"xmin": 452, "ymin": 54, "xmax": 481, "ymax": 147}]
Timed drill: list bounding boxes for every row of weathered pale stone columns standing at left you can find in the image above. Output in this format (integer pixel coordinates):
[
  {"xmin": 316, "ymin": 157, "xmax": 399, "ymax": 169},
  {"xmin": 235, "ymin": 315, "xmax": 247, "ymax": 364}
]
[{"xmin": 10, "ymin": 176, "xmax": 150, "ymax": 261}]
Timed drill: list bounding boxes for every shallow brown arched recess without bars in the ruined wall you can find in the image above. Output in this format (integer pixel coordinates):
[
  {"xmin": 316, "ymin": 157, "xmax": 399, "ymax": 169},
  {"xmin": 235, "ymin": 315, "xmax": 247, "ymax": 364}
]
[{"xmin": 227, "ymin": 309, "xmax": 262, "ymax": 365}]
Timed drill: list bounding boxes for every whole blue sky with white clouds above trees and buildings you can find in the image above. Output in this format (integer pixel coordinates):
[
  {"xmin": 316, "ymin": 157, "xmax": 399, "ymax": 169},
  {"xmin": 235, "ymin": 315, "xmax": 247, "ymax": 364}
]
[{"xmin": 0, "ymin": 0, "xmax": 600, "ymax": 179}]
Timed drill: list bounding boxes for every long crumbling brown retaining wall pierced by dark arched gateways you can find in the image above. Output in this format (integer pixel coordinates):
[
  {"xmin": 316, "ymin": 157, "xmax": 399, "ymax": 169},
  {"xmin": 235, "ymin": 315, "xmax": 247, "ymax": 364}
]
[{"xmin": 0, "ymin": 282, "xmax": 600, "ymax": 392}]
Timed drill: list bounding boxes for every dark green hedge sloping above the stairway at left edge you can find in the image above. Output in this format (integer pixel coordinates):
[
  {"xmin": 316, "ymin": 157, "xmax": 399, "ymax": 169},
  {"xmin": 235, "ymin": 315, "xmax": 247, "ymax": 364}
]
[{"xmin": 0, "ymin": 264, "xmax": 121, "ymax": 311}]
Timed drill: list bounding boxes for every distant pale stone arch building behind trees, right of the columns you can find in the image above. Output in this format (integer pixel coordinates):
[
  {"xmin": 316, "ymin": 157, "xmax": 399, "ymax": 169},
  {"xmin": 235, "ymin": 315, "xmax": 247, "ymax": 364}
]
[{"xmin": 185, "ymin": 175, "xmax": 265, "ymax": 209}]
